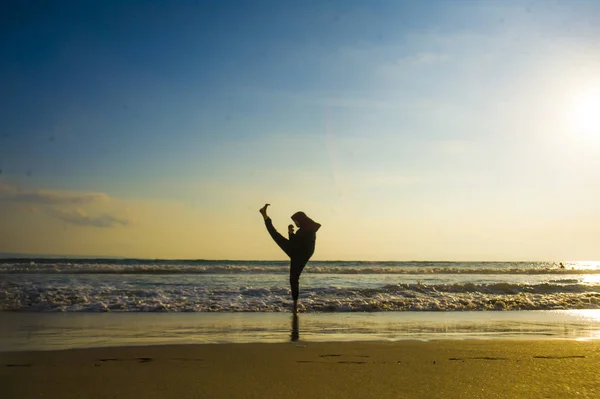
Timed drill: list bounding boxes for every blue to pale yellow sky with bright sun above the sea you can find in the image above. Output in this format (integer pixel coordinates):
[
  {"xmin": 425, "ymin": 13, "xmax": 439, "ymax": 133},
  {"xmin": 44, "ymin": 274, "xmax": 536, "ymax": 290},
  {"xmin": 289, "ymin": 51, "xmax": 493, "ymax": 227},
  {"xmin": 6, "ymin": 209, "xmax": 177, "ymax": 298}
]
[{"xmin": 0, "ymin": 1, "xmax": 600, "ymax": 260}]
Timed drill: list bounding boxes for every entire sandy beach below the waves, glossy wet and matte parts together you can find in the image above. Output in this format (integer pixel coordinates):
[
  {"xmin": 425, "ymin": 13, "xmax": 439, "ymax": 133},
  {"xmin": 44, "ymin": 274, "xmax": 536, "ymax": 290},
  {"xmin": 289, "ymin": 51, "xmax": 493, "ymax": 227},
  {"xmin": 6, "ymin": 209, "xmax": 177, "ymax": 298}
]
[{"xmin": 0, "ymin": 310, "xmax": 600, "ymax": 398}]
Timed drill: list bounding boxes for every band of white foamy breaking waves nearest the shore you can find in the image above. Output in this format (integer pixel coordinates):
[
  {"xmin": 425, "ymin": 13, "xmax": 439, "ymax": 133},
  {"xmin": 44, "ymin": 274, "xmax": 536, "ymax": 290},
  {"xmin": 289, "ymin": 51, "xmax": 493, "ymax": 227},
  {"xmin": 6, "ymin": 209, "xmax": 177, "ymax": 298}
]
[{"xmin": 0, "ymin": 282, "xmax": 600, "ymax": 312}]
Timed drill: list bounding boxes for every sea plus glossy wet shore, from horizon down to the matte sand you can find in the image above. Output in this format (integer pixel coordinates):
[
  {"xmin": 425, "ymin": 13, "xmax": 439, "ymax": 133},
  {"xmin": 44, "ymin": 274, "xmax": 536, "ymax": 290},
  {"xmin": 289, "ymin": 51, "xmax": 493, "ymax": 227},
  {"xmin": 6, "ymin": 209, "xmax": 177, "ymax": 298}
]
[{"xmin": 0, "ymin": 259, "xmax": 600, "ymax": 351}]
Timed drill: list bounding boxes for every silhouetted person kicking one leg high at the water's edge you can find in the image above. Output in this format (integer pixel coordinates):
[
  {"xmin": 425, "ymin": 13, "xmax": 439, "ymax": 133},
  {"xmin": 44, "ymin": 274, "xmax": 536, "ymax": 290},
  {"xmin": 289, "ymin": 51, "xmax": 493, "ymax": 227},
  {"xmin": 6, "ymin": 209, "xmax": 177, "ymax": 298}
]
[{"xmin": 260, "ymin": 204, "xmax": 321, "ymax": 313}]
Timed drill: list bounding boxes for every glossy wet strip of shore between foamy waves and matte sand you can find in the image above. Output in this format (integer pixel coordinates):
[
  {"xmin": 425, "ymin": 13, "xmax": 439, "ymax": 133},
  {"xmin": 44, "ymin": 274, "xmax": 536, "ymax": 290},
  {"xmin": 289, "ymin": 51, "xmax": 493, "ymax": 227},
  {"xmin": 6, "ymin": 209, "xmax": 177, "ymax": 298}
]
[{"xmin": 0, "ymin": 310, "xmax": 600, "ymax": 353}]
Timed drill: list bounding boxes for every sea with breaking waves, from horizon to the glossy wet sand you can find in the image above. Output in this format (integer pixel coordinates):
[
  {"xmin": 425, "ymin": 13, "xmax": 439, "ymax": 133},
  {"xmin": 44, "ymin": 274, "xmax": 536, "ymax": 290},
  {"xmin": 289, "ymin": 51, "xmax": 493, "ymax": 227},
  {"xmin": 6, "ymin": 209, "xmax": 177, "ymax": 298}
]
[{"xmin": 0, "ymin": 259, "xmax": 600, "ymax": 313}]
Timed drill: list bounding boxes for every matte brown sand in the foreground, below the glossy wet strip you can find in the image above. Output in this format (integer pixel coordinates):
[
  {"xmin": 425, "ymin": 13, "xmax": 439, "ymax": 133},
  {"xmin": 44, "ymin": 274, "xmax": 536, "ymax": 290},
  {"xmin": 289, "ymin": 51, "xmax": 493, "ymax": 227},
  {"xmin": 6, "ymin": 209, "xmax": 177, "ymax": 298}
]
[{"xmin": 0, "ymin": 340, "xmax": 600, "ymax": 399}]
